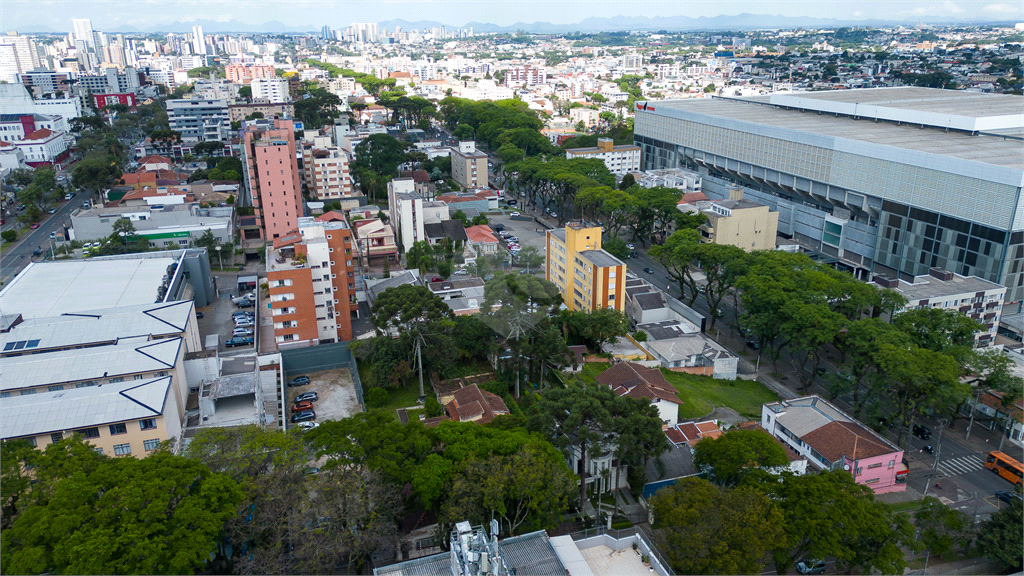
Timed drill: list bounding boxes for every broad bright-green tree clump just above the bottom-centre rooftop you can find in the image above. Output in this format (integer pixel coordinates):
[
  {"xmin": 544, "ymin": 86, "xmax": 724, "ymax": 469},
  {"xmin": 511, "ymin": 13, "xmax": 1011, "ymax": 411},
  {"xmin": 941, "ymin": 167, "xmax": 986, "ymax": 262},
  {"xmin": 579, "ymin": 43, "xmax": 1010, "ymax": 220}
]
[{"xmin": 306, "ymin": 412, "xmax": 575, "ymax": 536}]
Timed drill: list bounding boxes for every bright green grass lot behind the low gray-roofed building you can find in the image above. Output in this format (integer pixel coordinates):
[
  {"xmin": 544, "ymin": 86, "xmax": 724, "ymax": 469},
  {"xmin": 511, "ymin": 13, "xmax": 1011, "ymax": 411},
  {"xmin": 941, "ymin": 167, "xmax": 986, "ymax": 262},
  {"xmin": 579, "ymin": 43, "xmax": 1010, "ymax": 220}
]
[{"xmin": 662, "ymin": 368, "xmax": 778, "ymax": 420}]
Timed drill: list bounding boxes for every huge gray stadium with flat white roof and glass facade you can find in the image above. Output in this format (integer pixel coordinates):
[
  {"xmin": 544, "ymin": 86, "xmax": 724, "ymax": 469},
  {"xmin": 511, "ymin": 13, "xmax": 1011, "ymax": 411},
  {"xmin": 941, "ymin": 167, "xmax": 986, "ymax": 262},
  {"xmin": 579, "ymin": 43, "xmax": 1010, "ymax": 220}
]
[{"xmin": 634, "ymin": 87, "xmax": 1024, "ymax": 302}]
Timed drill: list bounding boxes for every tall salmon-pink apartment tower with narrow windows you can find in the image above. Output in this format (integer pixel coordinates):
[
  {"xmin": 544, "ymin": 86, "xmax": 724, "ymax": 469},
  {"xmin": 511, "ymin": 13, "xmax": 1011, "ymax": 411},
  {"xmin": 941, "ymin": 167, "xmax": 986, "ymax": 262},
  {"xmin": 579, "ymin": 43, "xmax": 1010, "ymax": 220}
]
[{"xmin": 243, "ymin": 120, "xmax": 302, "ymax": 240}]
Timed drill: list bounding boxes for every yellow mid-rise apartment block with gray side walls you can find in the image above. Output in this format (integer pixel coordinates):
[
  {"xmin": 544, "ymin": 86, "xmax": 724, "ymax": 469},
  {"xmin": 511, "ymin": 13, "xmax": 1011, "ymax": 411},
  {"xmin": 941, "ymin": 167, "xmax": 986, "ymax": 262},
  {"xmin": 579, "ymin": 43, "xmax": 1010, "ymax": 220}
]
[{"xmin": 545, "ymin": 222, "xmax": 626, "ymax": 312}]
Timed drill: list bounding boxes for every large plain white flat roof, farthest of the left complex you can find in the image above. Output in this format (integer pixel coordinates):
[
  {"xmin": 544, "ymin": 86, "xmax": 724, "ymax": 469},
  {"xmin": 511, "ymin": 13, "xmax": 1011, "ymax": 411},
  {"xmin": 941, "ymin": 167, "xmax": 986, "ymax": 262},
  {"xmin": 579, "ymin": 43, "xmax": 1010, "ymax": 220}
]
[{"xmin": 0, "ymin": 258, "xmax": 176, "ymax": 319}]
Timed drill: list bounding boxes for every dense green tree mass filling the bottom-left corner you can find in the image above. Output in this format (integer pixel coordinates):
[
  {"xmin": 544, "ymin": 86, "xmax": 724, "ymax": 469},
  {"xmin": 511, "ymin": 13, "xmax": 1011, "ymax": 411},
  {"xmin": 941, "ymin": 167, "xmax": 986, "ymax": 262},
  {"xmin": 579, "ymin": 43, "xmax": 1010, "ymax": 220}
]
[{"xmin": 0, "ymin": 437, "xmax": 243, "ymax": 574}]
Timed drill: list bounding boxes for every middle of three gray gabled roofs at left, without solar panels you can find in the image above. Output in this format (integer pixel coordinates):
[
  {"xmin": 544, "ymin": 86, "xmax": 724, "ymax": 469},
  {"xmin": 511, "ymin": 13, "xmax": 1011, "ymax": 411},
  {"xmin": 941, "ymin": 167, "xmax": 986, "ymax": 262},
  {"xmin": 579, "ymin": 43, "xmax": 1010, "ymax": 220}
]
[{"xmin": 0, "ymin": 336, "xmax": 184, "ymax": 390}]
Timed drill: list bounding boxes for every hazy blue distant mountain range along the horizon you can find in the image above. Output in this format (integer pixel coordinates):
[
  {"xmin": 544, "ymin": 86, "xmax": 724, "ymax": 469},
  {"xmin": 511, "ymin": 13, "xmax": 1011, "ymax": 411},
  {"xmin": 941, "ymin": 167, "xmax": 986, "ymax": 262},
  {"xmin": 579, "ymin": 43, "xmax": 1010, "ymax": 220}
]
[{"xmin": 17, "ymin": 13, "xmax": 1014, "ymax": 34}]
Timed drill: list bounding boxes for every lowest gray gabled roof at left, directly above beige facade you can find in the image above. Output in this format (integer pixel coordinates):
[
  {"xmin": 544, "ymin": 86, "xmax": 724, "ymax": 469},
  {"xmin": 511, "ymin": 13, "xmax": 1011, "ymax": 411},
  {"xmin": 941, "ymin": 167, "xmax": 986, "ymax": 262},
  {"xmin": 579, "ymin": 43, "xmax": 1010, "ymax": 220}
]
[{"xmin": 0, "ymin": 376, "xmax": 171, "ymax": 439}]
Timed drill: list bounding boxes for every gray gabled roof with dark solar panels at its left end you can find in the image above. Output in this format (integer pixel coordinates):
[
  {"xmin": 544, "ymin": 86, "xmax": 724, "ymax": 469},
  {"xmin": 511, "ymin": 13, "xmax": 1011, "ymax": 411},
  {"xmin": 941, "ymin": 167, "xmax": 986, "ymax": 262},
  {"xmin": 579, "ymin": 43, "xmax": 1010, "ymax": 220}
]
[{"xmin": 0, "ymin": 300, "xmax": 195, "ymax": 354}]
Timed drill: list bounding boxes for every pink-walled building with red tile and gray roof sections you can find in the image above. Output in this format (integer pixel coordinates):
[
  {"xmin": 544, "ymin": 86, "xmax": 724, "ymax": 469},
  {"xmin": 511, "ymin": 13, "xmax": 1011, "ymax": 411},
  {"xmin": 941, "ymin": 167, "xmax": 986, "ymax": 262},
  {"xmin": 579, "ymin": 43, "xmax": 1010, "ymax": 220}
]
[{"xmin": 761, "ymin": 396, "xmax": 906, "ymax": 494}]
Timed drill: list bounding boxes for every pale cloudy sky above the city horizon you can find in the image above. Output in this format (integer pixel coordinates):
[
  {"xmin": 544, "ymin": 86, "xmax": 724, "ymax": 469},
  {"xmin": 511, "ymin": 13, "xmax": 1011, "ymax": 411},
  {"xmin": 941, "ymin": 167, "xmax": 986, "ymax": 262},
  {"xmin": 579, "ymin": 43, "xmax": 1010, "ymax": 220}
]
[{"xmin": 0, "ymin": 0, "xmax": 1024, "ymax": 31}]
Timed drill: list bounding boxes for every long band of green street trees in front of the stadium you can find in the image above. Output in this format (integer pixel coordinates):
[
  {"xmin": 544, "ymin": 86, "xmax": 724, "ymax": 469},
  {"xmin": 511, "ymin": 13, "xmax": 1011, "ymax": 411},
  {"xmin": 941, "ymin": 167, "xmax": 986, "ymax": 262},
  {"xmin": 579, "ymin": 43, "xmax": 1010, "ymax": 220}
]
[{"xmin": 651, "ymin": 237, "xmax": 1021, "ymax": 444}]
